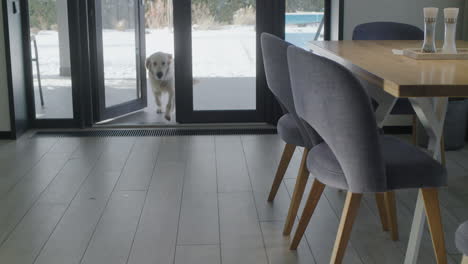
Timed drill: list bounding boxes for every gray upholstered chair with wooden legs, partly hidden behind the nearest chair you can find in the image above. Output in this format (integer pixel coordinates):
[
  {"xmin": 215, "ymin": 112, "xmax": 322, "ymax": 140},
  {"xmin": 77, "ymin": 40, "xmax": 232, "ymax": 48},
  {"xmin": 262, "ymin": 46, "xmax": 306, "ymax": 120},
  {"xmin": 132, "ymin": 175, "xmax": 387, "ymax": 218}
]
[{"xmin": 261, "ymin": 33, "xmax": 394, "ymax": 235}]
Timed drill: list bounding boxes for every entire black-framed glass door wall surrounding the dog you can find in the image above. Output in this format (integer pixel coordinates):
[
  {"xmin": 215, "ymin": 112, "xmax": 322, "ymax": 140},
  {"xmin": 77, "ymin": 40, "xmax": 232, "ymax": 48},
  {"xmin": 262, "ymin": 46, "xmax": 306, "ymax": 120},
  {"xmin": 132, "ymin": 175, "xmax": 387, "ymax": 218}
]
[{"xmin": 24, "ymin": 0, "xmax": 330, "ymax": 127}]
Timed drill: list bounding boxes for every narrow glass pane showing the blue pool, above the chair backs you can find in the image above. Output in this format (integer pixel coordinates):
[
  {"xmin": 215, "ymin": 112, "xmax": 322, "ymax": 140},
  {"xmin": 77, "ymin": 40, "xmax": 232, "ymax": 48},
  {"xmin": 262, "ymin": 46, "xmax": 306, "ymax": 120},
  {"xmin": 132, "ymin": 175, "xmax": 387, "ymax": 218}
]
[{"xmin": 285, "ymin": 0, "xmax": 325, "ymax": 49}]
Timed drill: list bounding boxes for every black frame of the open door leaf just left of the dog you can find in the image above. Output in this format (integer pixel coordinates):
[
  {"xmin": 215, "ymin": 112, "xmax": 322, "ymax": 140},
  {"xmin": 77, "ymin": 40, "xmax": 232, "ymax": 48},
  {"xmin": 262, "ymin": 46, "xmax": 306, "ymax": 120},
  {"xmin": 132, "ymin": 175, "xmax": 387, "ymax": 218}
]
[{"xmin": 88, "ymin": 0, "xmax": 147, "ymax": 123}]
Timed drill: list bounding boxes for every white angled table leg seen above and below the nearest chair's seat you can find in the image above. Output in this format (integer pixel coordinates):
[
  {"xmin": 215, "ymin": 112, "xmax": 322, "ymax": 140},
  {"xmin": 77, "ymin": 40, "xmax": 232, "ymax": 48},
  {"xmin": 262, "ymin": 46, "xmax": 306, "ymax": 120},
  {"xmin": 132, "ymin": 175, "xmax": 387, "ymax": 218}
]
[{"xmin": 405, "ymin": 98, "xmax": 448, "ymax": 264}]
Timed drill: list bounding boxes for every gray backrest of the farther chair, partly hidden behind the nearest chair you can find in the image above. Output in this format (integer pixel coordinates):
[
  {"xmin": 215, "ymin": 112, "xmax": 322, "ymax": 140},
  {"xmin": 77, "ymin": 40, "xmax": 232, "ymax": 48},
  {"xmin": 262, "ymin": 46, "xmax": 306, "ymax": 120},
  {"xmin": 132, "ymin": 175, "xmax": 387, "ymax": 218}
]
[{"xmin": 261, "ymin": 33, "xmax": 322, "ymax": 148}]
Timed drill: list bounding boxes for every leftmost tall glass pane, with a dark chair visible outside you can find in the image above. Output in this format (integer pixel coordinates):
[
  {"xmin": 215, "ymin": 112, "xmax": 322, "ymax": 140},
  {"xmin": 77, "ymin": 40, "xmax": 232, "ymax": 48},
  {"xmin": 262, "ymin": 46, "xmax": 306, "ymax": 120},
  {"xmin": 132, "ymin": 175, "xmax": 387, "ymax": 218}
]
[{"xmin": 28, "ymin": 0, "xmax": 73, "ymax": 119}]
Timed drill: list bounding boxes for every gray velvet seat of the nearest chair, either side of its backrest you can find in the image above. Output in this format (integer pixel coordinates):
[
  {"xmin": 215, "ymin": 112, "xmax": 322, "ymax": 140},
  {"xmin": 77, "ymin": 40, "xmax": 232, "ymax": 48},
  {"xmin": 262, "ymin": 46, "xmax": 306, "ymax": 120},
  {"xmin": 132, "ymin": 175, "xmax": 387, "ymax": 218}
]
[{"xmin": 307, "ymin": 136, "xmax": 447, "ymax": 190}]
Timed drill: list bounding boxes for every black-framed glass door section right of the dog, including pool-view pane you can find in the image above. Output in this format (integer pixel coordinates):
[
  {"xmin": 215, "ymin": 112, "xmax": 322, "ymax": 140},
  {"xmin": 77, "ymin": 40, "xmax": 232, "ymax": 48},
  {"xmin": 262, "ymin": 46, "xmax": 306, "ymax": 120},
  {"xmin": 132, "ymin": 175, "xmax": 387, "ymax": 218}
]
[{"xmin": 174, "ymin": 0, "xmax": 329, "ymax": 122}]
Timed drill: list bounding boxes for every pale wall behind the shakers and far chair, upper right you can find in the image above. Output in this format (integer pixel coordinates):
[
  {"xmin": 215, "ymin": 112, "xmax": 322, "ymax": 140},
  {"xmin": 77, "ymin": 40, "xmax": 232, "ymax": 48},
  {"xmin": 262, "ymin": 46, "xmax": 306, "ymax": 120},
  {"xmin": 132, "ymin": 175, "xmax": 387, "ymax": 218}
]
[{"xmin": 343, "ymin": 0, "xmax": 468, "ymax": 39}]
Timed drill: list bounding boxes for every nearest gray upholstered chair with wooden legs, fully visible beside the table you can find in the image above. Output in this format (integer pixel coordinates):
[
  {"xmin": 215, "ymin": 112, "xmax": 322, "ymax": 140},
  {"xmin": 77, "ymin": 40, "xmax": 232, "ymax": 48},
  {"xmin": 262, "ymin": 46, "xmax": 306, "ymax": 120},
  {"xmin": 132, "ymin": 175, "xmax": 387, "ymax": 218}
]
[{"xmin": 288, "ymin": 47, "xmax": 447, "ymax": 263}]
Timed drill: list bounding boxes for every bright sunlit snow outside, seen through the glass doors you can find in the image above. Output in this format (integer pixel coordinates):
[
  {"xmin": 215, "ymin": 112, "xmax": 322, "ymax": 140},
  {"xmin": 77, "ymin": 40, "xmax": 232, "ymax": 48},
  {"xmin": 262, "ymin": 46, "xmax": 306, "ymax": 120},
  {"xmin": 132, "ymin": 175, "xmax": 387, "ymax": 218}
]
[{"xmin": 36, "ymin": 25, "xmax": 317, "ymax": 79}]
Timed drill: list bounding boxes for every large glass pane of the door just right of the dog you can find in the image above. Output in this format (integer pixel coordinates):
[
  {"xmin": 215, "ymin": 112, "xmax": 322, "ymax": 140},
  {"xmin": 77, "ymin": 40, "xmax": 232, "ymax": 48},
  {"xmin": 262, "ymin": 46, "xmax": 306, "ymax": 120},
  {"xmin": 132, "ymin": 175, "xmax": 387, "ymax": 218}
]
[{"xmin": 192, "ymin": 0, "xmax": 256, "ymax": 111}]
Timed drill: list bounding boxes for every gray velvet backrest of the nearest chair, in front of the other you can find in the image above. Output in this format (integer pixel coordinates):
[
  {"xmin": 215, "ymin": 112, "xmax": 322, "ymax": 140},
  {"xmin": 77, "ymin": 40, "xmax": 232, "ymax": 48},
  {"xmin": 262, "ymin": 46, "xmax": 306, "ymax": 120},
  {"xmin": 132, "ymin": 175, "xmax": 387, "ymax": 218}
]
[{"xmin": 288, "ymin": 47, "xmax": 387, "ymax": 193}]
